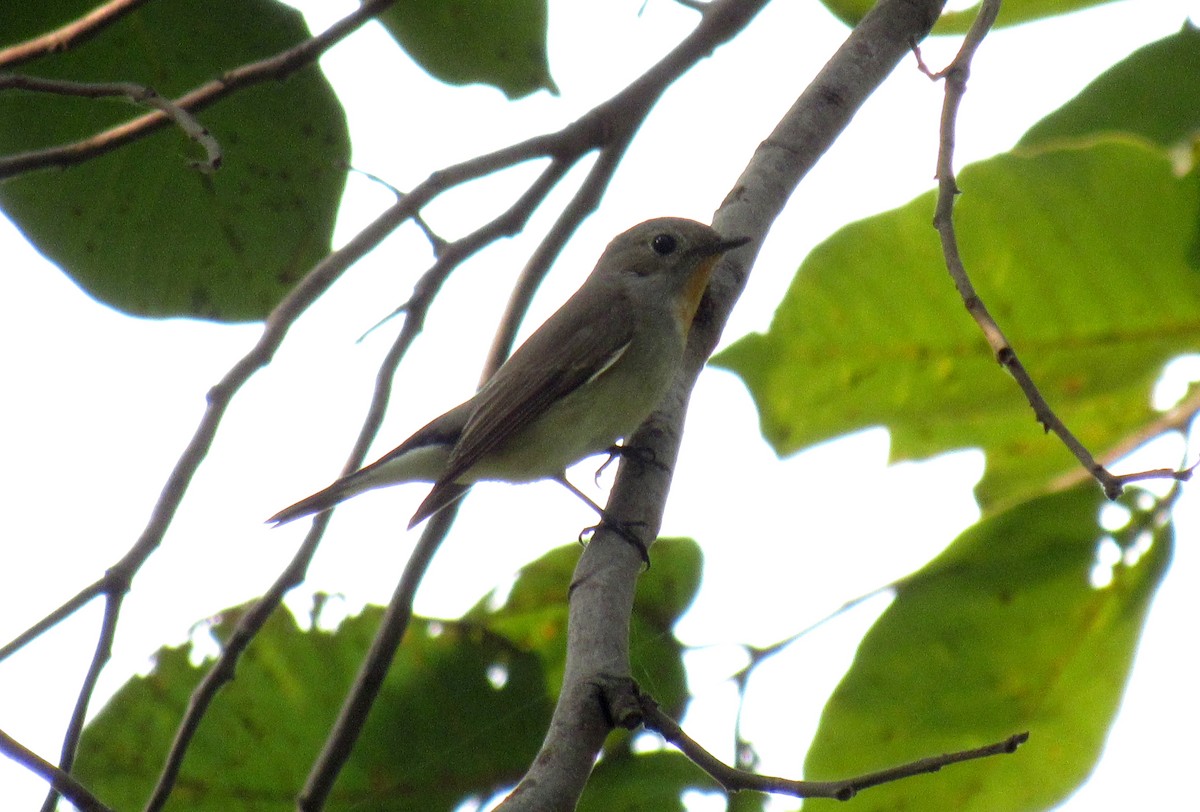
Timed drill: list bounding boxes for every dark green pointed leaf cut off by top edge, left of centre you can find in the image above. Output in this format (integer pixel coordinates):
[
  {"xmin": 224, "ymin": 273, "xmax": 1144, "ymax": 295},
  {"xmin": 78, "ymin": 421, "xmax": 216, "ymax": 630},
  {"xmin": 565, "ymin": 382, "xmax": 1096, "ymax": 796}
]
[{"xmin": 379, "ymin": 0, "xmax": 558, "ymax": 98}]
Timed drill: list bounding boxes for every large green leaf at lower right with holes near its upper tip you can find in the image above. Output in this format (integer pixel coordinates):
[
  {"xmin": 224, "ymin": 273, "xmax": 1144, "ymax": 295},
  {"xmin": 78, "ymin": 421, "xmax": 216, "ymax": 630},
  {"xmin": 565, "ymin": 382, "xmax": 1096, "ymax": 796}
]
[{"xmin": 804, "ymin": 487, "xmax": 1174, "ymax": 812}]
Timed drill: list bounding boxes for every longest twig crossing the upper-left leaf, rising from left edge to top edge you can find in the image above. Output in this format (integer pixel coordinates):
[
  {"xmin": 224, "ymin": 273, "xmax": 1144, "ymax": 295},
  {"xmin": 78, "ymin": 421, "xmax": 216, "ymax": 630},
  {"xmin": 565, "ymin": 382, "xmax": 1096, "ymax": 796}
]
[{"xmin": 0, "ymin": 0, "xmax": 396, "ymax": 180}]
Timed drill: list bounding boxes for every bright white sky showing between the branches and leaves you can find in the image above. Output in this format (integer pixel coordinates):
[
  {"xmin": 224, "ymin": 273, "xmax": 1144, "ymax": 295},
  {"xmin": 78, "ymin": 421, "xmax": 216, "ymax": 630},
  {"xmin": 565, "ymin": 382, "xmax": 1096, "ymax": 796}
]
[{"xmin": 0, "ymin": 0, "xmax": 1200, "ymax": 811}]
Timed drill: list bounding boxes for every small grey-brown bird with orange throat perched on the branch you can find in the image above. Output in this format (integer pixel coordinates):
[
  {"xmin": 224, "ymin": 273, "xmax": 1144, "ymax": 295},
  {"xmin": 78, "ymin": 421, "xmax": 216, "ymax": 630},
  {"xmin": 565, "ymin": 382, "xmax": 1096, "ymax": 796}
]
[{"xmin": 268, "ymin": 217, "xmax": 749, "ymax": 528}]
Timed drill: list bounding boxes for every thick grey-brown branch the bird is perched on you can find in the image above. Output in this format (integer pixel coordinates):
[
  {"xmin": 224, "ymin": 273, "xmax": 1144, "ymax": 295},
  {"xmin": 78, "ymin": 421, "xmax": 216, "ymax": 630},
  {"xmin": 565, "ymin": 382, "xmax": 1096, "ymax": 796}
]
[{"xmin": 499, "ymin": 0, "xmax": 942, "ymax": 812}]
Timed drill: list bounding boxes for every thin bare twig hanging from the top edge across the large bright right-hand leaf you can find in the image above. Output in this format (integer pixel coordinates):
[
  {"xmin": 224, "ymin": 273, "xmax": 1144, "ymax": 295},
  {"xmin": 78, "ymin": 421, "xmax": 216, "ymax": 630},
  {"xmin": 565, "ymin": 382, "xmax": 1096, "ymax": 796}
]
[{"xmin": 922, "ymin": 0, "xmax": 1192, "ymax": 499}]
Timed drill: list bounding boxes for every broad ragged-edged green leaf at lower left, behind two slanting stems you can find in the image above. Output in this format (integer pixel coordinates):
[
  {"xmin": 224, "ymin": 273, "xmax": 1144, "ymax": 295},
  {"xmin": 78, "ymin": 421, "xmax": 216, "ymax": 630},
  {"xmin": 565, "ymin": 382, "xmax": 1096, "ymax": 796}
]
[{"xmin": 70, "ymin": 607, "xmax": 552, "ymax": 812}]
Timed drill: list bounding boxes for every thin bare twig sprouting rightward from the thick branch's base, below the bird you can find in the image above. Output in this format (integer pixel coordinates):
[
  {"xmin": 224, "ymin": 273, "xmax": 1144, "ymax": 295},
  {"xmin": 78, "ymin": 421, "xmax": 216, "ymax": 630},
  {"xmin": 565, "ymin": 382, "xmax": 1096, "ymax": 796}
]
[{"xmin": 638, "ymin": 693, "xmax": 1030, "ymax": 801}]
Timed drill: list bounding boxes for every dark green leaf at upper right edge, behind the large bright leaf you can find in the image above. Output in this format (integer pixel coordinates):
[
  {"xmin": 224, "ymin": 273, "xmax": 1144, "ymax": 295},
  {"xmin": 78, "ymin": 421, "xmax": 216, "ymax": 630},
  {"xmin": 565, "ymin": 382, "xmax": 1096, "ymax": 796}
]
[{"xmin": 1018, "ymin": 22, "xmax": 1200, "ymax": 148}]
